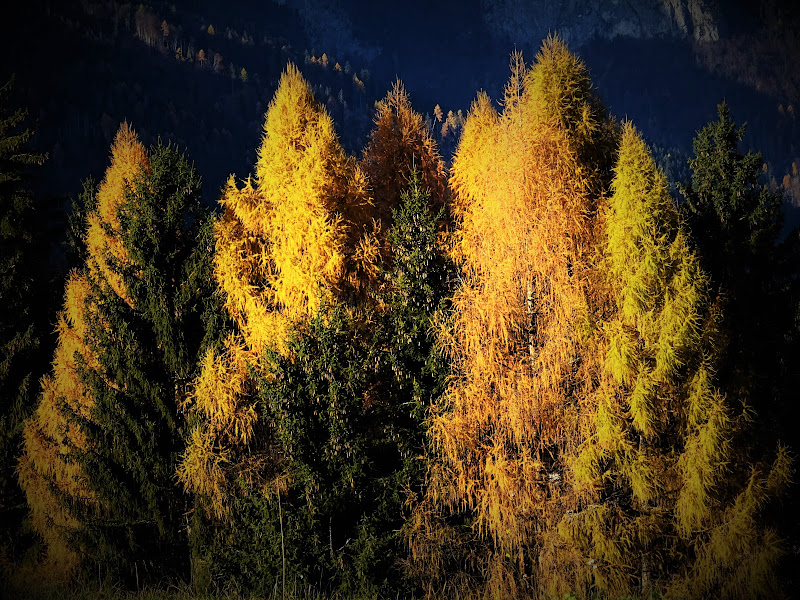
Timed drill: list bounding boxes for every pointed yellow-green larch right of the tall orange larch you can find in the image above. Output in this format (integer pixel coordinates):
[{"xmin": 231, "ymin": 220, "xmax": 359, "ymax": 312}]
[{"xmin": 559, "ymin": 123, "xmax": 788, "ymax": 598}]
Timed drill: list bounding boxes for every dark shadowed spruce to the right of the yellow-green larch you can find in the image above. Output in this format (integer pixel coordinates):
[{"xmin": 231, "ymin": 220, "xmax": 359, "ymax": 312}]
[{"xmin": 681, "ymin": 103, "xmax": 784, "ymax": 408}]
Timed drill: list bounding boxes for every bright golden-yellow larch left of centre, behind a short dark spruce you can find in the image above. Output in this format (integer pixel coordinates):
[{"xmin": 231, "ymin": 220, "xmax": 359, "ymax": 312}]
[{"xmin": 178, "ymin": 64, "xmax": 379, "ymax": 519}]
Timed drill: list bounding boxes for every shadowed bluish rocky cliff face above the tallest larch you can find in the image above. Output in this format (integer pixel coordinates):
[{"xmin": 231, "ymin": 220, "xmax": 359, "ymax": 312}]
[{"xmin": 482, "ymin": 0, "xmax": 720, "ymax": 47}]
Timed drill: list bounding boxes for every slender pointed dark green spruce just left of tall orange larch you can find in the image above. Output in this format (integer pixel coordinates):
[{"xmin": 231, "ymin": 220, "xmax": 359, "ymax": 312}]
[{"xmin": 380, "ymin": 169, "xmax": 455, "ymax": 592}]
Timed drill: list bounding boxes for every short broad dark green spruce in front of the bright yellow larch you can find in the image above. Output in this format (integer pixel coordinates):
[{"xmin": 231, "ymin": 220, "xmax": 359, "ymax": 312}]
[{"xmin": 255, "ymin": 304, "xmax": 382, "ymax": 594}]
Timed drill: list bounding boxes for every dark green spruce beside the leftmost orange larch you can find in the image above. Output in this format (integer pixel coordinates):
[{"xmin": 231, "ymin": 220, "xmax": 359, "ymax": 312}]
[{"xmin": 70, "ymin": 144, "xmax": 219, "ymax": 585}]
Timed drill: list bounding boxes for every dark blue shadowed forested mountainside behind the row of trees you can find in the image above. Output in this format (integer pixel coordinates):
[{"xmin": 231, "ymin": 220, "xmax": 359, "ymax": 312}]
[{"xmin": 2, "ymin": 0, "xmax": 800, "ymax": 211}]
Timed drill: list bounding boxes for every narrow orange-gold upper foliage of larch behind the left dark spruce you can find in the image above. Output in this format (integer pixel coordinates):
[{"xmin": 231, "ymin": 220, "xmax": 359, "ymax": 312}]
[{"xmin": 86, "ymin": 123, "xmax": 149, "ymax": 303}]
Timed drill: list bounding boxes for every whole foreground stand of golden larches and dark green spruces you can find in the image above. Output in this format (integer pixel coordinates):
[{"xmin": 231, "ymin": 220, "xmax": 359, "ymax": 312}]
[{"xmin": 0, "ymin": 37, "xmax": 798, "ymax": 598}]
